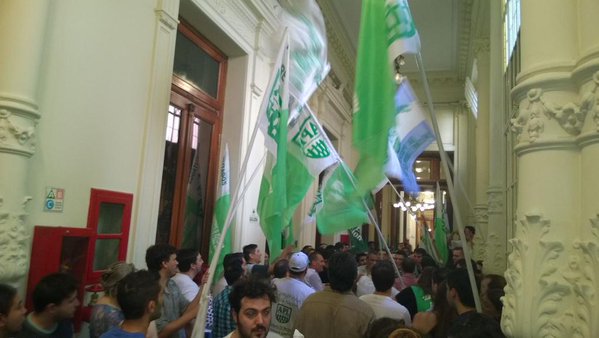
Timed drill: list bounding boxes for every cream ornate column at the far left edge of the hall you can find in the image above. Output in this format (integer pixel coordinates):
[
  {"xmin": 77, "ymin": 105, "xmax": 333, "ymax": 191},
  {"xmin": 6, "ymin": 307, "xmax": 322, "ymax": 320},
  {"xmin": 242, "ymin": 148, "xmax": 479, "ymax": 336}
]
[{"xmin": 0, "ymin": 0, "xmax": 50, "ymax": 287}]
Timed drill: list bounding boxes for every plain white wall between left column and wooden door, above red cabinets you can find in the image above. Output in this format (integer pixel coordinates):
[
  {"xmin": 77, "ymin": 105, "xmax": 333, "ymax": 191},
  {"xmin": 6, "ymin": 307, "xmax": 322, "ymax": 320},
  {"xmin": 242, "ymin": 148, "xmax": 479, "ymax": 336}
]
[{"xmin": 29, "ymin": 0, "xmax": 156, "ymax": 227}]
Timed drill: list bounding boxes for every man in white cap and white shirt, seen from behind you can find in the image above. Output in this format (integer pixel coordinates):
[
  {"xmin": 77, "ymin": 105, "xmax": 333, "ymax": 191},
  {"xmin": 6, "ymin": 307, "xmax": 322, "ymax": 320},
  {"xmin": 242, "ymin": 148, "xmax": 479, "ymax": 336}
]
[{"xmin": 270, "ymin": 252, "xmax": 315, "ymax": 337}]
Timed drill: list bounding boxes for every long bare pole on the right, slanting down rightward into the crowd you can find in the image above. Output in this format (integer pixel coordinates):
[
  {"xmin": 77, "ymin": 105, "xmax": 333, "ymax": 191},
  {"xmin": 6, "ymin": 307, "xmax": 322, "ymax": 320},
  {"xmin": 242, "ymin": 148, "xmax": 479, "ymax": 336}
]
[{"xmin": 416, "ymin": 53, "xmax": 482, "ymax": 312}]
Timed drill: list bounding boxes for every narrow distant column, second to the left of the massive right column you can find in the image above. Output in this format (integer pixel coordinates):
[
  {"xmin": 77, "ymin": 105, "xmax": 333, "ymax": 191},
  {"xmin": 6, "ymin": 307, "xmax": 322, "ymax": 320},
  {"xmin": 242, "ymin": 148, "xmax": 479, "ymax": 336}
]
[{"xmin": 472, "ymin": 39, "xmax": 490, "ymax": 265}]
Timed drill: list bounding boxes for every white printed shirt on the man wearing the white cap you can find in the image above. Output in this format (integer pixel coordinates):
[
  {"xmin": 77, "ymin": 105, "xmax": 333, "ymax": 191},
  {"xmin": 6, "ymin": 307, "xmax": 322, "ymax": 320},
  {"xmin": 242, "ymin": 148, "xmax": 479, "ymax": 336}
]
[{"xmin": 270, "ymin": 277, "xmax": 315, "ymax": 338}]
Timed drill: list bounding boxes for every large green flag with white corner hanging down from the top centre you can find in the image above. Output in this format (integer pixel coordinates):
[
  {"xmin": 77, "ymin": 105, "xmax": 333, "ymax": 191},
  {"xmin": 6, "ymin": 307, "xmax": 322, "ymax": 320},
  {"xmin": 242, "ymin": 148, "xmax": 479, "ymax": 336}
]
[{"xmin": 353, "ymin": 0, "xmax": 420, "ymax": 193}]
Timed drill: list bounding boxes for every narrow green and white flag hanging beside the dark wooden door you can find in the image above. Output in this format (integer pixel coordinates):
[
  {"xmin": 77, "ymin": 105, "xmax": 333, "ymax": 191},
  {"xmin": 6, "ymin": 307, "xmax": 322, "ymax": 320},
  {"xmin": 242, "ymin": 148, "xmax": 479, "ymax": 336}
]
[{"xmin": 209, "ymin": 144, "xmax": 231, "ymax": 280}]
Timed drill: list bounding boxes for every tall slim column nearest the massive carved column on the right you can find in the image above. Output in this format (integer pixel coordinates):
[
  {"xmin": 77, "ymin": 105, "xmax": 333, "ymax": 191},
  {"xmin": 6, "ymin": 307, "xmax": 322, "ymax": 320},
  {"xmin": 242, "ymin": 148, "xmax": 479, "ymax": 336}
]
[{"xmin": 484, "ymin": 1, "xmax": 507, "ymax": 275}]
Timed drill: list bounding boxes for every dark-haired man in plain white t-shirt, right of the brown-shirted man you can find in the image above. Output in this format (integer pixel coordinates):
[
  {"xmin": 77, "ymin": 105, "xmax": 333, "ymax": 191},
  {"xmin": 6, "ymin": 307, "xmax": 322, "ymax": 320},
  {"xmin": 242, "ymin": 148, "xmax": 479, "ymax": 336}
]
[{"xmin": 360, "ymin": 261, "xmax": 412, "ymax": 326}]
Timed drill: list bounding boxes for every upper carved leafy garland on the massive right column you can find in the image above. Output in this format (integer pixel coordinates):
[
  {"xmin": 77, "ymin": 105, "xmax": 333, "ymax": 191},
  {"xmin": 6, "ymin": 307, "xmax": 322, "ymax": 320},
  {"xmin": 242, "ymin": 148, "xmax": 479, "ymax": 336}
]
[{"xmin": 511, "ymin": 83, "xmax": 598, "ymax": 143}]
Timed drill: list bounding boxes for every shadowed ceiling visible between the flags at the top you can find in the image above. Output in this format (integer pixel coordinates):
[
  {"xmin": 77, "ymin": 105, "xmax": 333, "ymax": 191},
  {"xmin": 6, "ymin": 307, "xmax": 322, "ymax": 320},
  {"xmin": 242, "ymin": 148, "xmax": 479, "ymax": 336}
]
[{"xmin": 318, "ymin": 0, "xmax": 488, "ymax": 88}]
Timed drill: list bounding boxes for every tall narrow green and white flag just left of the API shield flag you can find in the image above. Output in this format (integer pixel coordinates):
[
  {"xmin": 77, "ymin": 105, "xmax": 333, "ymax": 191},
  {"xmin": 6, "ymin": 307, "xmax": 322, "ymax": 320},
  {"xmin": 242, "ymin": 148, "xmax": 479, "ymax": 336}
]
[{"xmin": 258, "ymin": 33, "xmax": 289, "ymax": 259}]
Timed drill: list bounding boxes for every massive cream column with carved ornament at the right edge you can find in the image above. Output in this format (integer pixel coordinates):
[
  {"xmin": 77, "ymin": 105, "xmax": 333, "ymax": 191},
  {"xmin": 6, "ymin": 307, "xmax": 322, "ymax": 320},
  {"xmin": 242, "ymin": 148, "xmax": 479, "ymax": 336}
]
[{"xmin": 502, "ymin": 0, "xmax": 599, "ymax": 337}]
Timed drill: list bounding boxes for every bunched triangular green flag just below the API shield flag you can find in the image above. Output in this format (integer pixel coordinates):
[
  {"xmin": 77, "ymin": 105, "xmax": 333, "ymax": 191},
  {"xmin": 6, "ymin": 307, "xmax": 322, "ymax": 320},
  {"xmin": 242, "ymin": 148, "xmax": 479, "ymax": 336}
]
[{"xmin": 312, "ymin": 162, "xmax": 369, "ymax": 235}]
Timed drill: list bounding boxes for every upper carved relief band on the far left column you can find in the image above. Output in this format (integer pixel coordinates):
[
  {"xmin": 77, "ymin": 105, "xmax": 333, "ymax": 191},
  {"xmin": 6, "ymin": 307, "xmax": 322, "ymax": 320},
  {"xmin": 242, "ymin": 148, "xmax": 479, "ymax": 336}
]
[{"xmin": 0, "ymin": 109, "xmax": 37, "ymax": 157}]
